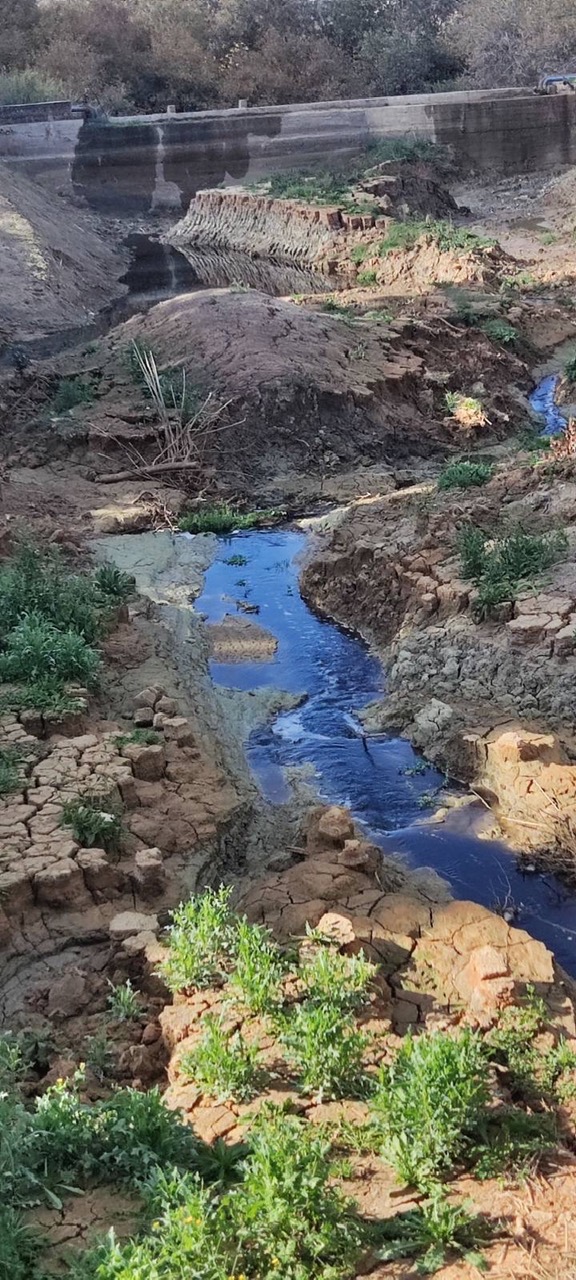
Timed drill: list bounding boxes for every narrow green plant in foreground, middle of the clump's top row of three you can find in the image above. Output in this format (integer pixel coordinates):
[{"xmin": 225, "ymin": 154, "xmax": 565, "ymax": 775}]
[{"xmin": 230, "ymin": 920, "xmax": 287, "ymax": 1014}]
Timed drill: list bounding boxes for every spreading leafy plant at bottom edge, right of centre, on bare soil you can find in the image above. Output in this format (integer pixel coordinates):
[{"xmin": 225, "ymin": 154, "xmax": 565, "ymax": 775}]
[{"xmin": 378, "ymin": 1187, "xmax": 492, "ymax": 1275}]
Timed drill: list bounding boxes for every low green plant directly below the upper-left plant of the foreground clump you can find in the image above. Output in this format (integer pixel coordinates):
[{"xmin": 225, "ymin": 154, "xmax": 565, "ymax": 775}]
[{"xmin": 180, "ymin": 1014, "xmax": 259, "ymax": 1102}]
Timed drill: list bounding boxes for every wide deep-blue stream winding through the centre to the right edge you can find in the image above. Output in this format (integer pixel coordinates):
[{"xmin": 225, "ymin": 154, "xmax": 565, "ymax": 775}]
[{"xmin": 197, "ymin": 519, "xmax": 576, "ymax": 974}]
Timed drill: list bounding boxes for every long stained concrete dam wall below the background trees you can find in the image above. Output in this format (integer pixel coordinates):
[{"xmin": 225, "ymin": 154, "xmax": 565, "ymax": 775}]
[{"xmin": 0, "ymin": 88, "xmax": 576, "ymax": 216}]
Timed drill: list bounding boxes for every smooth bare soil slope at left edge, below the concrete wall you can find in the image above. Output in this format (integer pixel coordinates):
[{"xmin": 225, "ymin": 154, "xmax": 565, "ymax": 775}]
[{"xmin": 0, "ymin": 165, "xmax": 124, "ymax": 352}]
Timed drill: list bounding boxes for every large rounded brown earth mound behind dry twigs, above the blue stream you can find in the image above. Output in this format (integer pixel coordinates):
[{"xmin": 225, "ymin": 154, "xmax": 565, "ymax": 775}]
[{"xmin": 83, "ymin": 291, "xmax": 527, "ymax": 493}]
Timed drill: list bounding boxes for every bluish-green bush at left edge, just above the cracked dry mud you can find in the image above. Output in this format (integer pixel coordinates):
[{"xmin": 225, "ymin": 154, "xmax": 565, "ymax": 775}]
[{"xmin": 0, "ymin": 613, "xmax": 100, "ymax": 689}]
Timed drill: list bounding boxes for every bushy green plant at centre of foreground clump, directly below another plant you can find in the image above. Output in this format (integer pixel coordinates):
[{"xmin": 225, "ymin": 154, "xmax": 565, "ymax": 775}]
[{"xmin": 280, "ymin": 1001, "xmax": 367, "ymax": 1098}]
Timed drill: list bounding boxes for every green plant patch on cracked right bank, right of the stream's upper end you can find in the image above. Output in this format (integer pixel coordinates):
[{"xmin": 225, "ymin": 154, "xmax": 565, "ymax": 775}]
[{"xmin": 457, "ymin": 525, "xmax": 567, "ymax": 621}]
